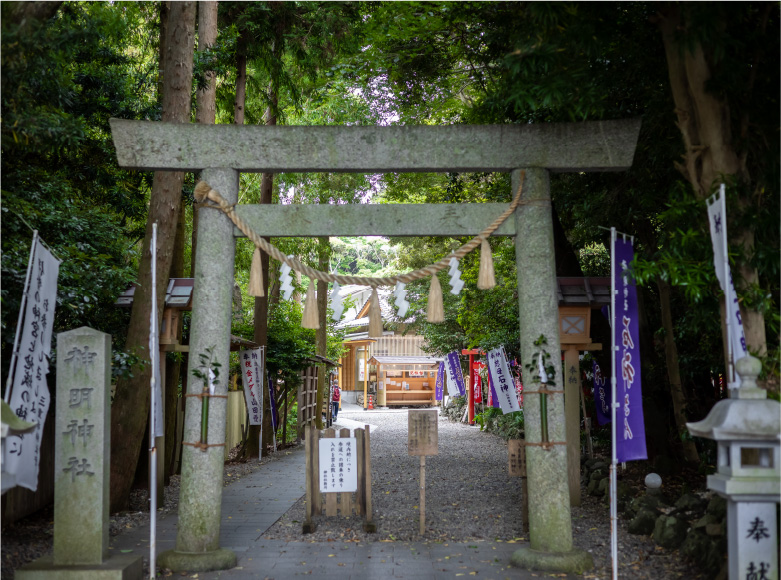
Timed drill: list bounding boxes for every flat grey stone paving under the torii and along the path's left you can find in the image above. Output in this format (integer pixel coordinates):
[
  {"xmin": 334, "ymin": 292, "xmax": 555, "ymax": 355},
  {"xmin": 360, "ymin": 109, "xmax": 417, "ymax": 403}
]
[{"xmin": 106, "ymin": 406, "xmax": 575, "ymax": 580}]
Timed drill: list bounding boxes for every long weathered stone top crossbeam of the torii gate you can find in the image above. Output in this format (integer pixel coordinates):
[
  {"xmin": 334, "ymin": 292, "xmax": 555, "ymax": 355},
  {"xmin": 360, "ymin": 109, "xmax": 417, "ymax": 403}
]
[{"xmin": 110, "ymin": 119, "xmax": 640, "ymax": 173}]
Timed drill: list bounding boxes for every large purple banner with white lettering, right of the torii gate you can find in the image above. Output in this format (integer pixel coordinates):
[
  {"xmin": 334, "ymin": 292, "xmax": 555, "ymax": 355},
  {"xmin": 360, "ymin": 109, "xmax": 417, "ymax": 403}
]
[{"xmin": 612, "ymin": 239, "xmax": 648, "ymax": 462}]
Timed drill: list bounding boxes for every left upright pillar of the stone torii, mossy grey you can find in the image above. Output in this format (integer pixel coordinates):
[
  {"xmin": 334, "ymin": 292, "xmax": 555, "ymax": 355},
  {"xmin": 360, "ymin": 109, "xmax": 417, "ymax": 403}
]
[{"xmin": 158, "ymin": 169, "xmax": 239, "ymax": 572}]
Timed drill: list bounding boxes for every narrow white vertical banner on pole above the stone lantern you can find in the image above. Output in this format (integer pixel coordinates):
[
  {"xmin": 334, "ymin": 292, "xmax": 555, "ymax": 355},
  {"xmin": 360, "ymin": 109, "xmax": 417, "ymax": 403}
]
[{"xmin": 707, "ymin": 184, "xmax": 748, "ymax": 389}]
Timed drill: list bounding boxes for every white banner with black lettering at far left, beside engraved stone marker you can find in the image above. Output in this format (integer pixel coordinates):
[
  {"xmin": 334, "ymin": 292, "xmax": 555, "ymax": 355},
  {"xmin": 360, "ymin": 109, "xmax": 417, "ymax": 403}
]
[{"xmin": 2, "ymin": 236, "xmax": 59, "ymax": 491}]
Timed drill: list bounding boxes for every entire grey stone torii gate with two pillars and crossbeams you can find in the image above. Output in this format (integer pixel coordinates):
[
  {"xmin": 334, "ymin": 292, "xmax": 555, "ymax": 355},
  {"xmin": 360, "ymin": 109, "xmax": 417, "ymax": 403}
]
[{"xmin": 111, "ymin": 119, "xmax": 640, "ymax": 572}]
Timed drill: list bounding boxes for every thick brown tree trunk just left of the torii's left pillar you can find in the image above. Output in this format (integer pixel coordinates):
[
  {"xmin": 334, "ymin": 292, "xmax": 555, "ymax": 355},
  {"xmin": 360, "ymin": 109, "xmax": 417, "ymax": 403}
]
[{"xmin": 110, "ymin": 2, "xmax": 195, "ymax": 511}]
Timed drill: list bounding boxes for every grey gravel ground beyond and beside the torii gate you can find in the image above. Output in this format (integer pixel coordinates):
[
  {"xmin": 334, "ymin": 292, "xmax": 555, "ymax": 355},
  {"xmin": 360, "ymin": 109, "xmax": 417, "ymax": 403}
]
[{"xmin": 2, "ymin": 410, "xmax": 704, "ymax": 580}]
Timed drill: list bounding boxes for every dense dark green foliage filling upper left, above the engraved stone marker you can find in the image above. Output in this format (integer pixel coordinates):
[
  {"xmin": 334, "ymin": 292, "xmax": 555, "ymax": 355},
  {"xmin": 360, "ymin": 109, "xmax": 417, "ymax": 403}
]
[{"xmin": 0, "ymin": 2, "xmax": 156, "ymax": 388}]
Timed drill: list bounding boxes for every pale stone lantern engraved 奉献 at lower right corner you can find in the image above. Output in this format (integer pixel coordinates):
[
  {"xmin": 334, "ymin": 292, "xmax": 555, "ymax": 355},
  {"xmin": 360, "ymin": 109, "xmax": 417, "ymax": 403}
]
[{"xmin": 687, "ymin": 356, "xmax": 781, "ymax": 580}]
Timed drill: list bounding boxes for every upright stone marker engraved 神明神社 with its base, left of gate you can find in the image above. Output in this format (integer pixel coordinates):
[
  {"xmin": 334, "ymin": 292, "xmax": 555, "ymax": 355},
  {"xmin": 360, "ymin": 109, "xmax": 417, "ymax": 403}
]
[{"xmin": 16, "ymin": 328, "xmax": 143, "ymax": 580}]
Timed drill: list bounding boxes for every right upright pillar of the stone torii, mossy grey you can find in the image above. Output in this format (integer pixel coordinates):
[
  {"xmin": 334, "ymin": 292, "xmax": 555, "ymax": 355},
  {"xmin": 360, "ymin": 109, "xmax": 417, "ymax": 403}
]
[{"xmin": 512, "ymin": 167, "xmax": 593, "ymax": 573}]
